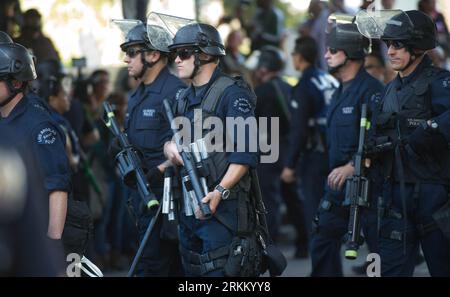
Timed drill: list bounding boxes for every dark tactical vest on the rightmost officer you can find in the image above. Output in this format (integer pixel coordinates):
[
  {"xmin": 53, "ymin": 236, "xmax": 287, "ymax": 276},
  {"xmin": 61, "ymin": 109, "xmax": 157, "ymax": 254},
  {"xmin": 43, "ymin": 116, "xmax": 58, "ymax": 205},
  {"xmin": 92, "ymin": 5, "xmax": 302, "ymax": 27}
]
[{"xmin": 376, "ymin": 67, "xmax": 450, "ymax": 184}]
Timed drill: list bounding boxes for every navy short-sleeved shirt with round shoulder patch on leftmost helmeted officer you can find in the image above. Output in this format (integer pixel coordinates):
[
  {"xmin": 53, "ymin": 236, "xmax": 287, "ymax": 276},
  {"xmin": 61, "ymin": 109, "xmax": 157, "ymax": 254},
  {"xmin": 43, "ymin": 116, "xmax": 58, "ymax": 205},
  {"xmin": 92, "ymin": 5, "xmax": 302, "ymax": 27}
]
[{"xmin": 0, "ymin": 95, "xmax": 71, "ymax": 194}]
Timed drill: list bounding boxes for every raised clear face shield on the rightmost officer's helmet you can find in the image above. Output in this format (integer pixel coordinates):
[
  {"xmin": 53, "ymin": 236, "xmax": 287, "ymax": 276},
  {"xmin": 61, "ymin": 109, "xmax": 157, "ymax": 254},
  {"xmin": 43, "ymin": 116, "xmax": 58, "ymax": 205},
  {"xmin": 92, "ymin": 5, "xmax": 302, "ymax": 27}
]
[{"xmin": 355, "ymin": 10, "xmax": 414, "ymax": 40}]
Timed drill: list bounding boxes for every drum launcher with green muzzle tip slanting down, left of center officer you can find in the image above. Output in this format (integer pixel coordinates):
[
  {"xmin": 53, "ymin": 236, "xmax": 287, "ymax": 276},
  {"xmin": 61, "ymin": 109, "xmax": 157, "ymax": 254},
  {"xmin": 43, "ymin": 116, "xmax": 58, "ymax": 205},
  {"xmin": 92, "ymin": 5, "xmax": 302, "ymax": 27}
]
[{"xmin": 103, "ymin": 102, "xmax": 159, "ymax": 209}]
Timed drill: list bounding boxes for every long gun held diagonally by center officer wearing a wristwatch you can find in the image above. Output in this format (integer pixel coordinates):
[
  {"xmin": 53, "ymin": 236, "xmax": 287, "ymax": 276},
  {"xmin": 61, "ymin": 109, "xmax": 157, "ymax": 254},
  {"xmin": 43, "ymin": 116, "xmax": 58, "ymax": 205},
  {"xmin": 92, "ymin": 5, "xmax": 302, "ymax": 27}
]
[{"xmin": 163, "ymin": 99, "xmax": 212, "ymax": 218}]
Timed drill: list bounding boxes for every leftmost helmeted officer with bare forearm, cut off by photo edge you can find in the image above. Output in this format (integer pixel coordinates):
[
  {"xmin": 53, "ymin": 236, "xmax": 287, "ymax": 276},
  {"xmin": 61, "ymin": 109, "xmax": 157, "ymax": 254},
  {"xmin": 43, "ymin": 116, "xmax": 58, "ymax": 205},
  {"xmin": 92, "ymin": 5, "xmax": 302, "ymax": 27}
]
[{"xmin": 0, "ymin": 31, "xmax": 70, "ymax": 240}]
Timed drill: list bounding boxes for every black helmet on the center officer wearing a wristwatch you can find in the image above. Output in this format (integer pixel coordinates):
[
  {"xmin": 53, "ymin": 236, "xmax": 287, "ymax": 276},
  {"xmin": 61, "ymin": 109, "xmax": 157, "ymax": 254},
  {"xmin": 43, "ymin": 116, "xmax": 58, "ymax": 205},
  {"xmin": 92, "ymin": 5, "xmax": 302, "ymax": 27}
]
[{"xmin": 169, "ymin": 23, "xmax": 225, "ymax": 56}]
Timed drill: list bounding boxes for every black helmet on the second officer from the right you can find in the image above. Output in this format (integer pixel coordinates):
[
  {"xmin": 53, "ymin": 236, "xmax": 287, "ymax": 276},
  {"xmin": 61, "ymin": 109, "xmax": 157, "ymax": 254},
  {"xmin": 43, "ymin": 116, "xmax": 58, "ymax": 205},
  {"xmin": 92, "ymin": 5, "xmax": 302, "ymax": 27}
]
[{"xmin": 327, "ymin": 23, "xmax": 370, "ymax": 60}]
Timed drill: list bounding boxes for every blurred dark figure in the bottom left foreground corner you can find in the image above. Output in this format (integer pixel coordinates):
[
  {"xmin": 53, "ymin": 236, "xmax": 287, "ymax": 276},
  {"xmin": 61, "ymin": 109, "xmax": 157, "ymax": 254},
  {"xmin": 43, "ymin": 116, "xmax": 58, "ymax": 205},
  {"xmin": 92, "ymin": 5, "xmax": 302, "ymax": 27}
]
[{"xmin": 0, "ymin": 125, "xmax": 67, "ymax": 277}]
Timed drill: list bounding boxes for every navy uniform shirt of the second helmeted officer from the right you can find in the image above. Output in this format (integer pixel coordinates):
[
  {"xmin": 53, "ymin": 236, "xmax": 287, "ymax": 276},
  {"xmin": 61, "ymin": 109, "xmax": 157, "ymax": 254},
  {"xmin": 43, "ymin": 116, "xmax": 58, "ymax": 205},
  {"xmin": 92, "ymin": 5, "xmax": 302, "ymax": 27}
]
[{"xmin": 327, "ymin": 67, "xmax": 383, "ymax": 169}]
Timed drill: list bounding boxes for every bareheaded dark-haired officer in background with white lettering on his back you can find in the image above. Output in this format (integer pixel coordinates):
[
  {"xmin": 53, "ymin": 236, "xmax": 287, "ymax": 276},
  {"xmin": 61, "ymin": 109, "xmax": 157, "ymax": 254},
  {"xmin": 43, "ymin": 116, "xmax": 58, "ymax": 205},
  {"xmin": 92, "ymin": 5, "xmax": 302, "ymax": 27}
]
[{"xmin": 281, "ymin": 37, "xmax": 339, "ymax": 242}]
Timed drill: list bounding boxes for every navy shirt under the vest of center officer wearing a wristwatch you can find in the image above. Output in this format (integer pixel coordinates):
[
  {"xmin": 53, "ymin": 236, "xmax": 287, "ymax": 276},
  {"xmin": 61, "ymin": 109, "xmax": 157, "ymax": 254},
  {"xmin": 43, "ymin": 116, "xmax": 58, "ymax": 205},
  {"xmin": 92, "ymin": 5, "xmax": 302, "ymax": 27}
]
[{"xmin": 178, "ymin": 67, "xmax": 258, "ymax": 168}]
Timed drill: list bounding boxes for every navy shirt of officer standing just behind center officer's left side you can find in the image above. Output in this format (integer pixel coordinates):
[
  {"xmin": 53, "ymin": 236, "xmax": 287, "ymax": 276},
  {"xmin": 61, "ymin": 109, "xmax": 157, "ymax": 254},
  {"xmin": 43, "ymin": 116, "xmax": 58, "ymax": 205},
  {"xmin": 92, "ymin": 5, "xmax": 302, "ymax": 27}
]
[{"xmin": 125, "ymin": 67, "xmax": 186, "ymax": 168}]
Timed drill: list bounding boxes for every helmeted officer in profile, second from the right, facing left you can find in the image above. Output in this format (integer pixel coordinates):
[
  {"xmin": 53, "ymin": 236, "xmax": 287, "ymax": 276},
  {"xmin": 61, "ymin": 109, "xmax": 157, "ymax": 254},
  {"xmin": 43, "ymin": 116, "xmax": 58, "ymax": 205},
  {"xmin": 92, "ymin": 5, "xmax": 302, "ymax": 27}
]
[{"xmin": 311, "ymin": 23, "xmax": 382, "ymax": 276}]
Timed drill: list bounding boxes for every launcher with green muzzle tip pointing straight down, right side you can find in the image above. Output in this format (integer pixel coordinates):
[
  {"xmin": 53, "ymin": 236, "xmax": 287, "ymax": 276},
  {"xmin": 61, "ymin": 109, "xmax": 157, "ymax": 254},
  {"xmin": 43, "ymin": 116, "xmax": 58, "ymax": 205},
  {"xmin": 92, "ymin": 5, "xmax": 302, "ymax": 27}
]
[{"xmin": 344, "ymin": 104, "xmax": 369, "ymax": 260}]
